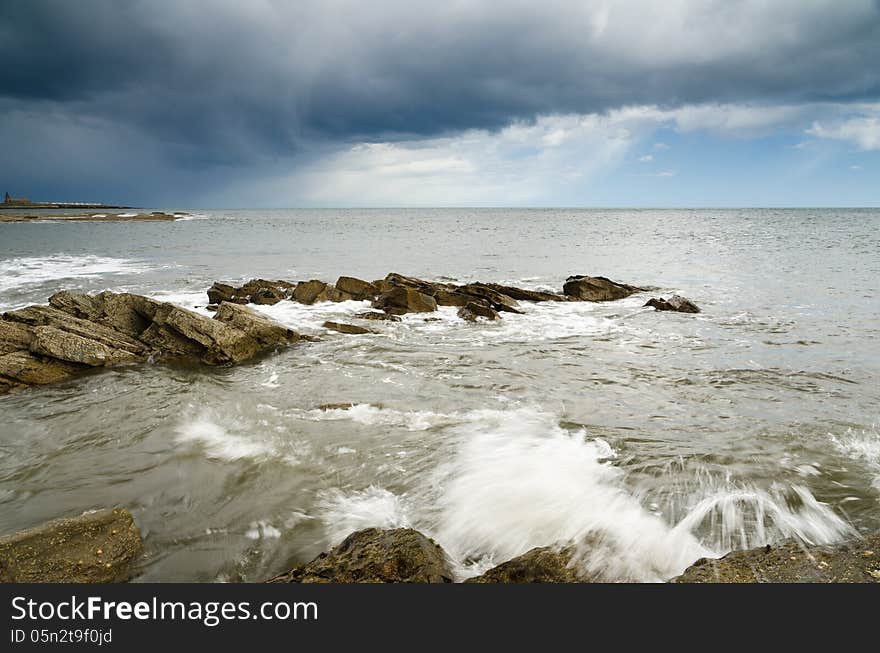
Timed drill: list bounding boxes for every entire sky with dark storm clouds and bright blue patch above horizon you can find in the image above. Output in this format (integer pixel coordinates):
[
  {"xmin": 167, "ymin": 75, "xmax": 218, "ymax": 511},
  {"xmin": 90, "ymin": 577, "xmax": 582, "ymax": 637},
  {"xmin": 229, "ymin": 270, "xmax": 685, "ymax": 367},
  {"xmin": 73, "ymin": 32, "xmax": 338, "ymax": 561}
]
[{"xmin": 0, "ymin": 0, "xmax": 880, "ymax": 208}]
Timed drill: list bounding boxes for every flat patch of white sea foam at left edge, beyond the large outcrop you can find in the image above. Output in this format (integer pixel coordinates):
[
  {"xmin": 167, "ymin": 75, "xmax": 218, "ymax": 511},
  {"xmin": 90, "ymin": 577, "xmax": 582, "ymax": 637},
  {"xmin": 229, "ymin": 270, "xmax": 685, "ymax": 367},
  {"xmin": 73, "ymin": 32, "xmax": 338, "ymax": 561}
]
[{"xmin": 0, "ymin": 254, "xmax": 146, "ymax": 292}]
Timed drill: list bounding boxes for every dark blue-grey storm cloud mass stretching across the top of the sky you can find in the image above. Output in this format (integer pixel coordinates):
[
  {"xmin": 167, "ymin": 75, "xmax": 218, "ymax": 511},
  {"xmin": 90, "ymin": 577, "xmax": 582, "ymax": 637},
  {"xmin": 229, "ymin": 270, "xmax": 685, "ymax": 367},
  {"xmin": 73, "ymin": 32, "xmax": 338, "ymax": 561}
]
[{"xmin": 0, "ymin": 0, "xmax": 880, "ymax": 202}]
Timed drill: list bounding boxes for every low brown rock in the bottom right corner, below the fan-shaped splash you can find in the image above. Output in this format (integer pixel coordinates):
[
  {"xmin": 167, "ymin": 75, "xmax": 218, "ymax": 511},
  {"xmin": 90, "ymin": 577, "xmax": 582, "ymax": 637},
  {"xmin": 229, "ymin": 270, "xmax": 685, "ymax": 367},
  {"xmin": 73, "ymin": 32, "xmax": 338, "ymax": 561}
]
[{"xmin": 672, "ymin": 533, "xmax": 880, "ymax": 583}]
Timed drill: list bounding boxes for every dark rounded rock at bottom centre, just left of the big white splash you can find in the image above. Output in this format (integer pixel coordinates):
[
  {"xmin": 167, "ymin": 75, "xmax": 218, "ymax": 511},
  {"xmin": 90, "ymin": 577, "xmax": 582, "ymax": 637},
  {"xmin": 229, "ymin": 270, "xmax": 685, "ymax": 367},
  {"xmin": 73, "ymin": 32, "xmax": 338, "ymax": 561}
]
[{"xmin": 269, "ymin": 528, "xmax": 452, "ymax": 583}]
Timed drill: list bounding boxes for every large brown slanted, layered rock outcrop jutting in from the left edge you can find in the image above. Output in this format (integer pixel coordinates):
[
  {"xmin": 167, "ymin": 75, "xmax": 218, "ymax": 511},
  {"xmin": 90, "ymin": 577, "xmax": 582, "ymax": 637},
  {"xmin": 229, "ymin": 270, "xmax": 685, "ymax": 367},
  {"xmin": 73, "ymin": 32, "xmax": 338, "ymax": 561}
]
[{"xmin": 0, "ymin": 292, "xmax": 300, "ymax": 393}]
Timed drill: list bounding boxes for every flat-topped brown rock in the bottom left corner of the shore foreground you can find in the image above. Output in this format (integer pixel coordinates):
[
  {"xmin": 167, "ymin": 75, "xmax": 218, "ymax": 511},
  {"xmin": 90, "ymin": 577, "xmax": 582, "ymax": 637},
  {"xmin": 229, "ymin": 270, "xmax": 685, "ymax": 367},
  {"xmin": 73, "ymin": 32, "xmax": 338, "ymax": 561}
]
[{"xmin": 0, "ymin": 508, "xmax": 143, "ymax": 583}]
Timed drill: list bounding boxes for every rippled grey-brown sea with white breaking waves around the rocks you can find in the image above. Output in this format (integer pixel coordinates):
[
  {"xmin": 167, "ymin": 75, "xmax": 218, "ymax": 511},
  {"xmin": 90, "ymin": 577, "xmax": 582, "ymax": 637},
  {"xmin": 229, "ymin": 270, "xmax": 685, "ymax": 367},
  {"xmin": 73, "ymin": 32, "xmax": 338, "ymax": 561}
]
[{"xmin": 0, "ymin": 209, "xmax": 880, "ymax": 581}]
